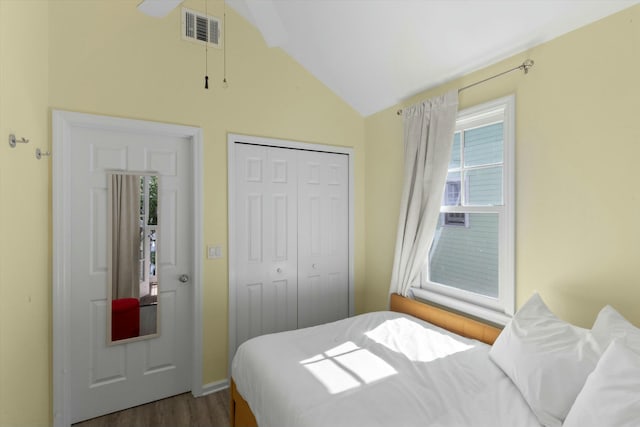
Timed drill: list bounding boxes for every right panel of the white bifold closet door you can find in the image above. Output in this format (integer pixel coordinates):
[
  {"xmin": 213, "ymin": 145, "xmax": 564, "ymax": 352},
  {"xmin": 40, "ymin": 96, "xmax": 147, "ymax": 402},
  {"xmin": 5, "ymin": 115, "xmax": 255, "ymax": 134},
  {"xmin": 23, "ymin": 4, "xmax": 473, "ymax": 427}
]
[{"xmin": 298, "ymin": 151, "xmax": 349, "ymax": 328}]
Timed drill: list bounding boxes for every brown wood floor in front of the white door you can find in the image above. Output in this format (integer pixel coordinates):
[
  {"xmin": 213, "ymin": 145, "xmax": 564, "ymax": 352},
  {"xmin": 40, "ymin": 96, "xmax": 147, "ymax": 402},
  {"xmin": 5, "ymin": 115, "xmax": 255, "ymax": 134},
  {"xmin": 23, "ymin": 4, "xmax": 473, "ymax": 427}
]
[{"xmin": 73, "ymin": 389, "xmax": 230, "ymax": 427}]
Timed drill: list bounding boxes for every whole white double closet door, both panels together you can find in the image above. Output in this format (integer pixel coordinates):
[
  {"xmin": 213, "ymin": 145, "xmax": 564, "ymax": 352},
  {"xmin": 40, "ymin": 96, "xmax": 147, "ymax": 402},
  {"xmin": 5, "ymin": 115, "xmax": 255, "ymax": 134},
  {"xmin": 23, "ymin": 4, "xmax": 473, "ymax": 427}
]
[{"xmin": 230, "ymin": 143, "xmax": 350, "ymax": 354}]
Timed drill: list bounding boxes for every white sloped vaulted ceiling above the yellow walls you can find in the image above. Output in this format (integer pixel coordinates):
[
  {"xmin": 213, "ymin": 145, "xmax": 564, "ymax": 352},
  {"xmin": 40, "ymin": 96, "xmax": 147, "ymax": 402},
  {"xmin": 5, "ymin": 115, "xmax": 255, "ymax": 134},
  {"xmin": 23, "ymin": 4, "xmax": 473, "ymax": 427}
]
[{"xmin": 227, "ymin": 0, "xmax": 640, "ymax": 116}]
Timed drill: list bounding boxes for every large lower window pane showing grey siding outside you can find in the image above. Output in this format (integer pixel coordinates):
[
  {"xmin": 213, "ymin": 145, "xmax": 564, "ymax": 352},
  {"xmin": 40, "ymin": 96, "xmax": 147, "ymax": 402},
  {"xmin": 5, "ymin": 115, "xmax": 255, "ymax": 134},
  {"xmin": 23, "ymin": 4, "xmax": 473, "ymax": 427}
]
[{"xmin": 429, "ymin": 213, "xmax": 498, "ymax": 298}]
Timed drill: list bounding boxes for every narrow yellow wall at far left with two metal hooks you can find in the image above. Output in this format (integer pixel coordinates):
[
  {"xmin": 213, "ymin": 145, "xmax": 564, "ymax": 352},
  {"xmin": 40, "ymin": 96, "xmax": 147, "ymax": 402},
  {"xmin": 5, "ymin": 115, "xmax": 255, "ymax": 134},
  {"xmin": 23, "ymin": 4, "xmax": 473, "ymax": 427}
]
[{"xmin": 0, "ymin": 0, "xmax": 51, "ymax": 426}]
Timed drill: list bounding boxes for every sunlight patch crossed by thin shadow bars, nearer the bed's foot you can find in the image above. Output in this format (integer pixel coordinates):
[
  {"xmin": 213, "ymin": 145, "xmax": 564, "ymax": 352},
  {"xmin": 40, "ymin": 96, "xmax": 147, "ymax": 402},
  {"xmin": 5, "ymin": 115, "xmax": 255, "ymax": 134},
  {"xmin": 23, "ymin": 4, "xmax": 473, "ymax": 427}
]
[{"xmin": 300, "ymin": 341, "xmax": 397, "ymax": 394}]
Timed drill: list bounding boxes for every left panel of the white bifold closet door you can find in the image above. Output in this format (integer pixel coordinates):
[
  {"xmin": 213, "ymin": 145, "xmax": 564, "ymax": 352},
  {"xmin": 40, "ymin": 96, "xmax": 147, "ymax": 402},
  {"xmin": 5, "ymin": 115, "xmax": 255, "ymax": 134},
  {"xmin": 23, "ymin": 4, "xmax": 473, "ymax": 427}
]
[{"xmin": 232, "ymin": 144, "xmax": 298, "ymax": 348}]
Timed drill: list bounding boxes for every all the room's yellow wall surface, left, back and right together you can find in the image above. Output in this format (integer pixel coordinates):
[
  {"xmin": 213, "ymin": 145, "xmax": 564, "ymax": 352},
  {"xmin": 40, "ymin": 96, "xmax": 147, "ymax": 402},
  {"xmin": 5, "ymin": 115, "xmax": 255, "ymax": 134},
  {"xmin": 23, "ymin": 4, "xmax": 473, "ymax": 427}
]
[{"xmin": 0, "ymin": 0, "xmax": 640, "ymax": 426}]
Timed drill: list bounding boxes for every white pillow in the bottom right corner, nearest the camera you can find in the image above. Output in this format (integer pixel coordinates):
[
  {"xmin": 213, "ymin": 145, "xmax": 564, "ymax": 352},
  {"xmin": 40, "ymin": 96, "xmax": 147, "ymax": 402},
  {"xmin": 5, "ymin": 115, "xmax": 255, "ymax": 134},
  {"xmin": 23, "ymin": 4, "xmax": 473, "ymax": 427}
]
[{"xmin": 563, "ymin": 339, "xmax": 640, "ymax": 427}]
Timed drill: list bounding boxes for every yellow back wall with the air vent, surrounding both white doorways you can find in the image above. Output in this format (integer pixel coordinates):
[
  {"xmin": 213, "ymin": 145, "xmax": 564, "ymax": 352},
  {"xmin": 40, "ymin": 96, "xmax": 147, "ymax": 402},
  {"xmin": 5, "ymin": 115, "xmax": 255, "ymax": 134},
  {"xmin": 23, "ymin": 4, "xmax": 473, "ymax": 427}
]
[{"xmin": 49, "ymin": 1, "xmax": 364, "ymax": 383}]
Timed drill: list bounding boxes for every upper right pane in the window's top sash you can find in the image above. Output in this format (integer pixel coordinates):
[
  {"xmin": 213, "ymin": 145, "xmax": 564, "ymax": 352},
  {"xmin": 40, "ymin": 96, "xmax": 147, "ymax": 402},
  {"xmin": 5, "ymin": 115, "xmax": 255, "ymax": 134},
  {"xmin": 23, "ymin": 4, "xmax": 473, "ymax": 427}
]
[{"xmin": 464, "ymin": 122, "xmax": 503, "ymax": 166}]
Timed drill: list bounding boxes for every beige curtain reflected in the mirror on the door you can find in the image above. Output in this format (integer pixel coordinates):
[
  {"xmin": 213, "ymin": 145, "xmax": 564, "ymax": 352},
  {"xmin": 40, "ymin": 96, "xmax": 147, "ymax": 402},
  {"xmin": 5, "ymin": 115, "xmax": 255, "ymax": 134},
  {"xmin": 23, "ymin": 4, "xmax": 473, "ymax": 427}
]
[{"xmin": 111, "ymin": 174, "xmax": 140, "ymax": 300}]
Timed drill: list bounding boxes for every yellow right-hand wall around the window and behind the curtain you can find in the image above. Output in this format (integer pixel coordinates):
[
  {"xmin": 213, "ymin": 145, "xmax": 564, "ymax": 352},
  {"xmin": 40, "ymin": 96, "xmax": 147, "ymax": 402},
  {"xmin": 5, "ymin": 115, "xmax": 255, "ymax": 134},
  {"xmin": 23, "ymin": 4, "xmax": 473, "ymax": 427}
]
[{"xmin": 365, "ymin": 6, "xmax": 640, "ymax": 326}]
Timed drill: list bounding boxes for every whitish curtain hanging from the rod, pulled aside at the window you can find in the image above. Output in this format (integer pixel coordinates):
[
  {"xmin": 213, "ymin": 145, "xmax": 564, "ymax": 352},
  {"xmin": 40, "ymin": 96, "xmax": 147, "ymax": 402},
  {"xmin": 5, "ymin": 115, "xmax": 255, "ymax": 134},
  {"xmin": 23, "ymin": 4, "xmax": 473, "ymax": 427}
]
[{"xmin": 389, "ymin": 90, "xmax": 458, "ymax": 296}]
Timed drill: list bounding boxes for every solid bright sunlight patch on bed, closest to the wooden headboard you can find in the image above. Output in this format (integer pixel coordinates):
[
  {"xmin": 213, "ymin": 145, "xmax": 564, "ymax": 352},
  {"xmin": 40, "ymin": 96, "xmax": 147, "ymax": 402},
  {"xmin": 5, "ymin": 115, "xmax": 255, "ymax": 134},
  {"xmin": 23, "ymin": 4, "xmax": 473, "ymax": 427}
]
[{"xmin": 365, "ymin": 317, "xmax": 474, "ymax": 362}]
